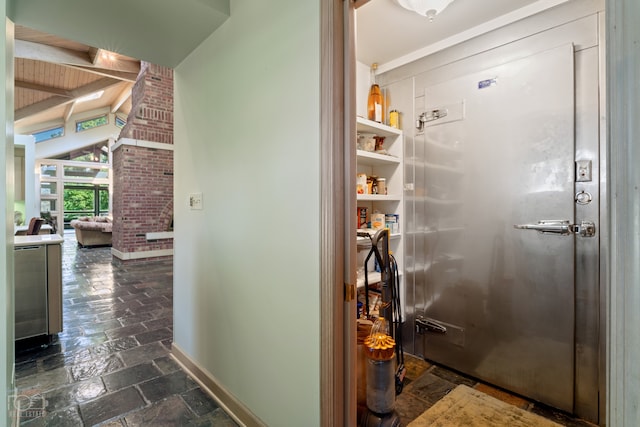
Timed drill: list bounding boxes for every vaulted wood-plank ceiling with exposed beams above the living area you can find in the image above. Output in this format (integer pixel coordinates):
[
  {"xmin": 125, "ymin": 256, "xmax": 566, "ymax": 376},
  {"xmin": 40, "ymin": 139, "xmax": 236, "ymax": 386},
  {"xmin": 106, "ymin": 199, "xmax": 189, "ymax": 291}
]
[{"xmin": 15, "ymin": 26, "xmax": 140, "ymax": 132}]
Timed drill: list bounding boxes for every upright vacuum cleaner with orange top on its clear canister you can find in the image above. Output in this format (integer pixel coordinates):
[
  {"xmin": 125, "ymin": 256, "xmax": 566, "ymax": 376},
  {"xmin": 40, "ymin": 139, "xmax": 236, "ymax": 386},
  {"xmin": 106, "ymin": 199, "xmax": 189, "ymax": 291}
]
[{"xmin": 358, "ymin": 229, "xmax": 406, "ymax": 427}]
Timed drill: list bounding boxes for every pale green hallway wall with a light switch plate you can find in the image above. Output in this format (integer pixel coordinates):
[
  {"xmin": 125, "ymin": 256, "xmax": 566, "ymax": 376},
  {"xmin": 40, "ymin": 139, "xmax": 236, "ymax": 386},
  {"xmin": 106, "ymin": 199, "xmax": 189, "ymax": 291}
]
[{"xmin": 174, "ymin": 0, "xmax": 321, "ymax": 427}]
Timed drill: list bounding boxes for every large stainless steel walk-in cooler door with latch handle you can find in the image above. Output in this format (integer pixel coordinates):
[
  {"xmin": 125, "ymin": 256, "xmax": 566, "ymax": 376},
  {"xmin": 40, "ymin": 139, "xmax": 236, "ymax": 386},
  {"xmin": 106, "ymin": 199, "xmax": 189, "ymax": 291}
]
[{"xmin": 416, "ymin": 45, "xmax": 579, "ymax": 411}]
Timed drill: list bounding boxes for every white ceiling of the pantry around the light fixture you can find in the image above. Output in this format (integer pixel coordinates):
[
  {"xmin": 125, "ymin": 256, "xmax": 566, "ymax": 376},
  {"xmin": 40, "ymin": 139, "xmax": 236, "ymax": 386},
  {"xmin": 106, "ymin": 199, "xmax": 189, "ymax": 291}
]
[{"xmin": 356, "ymin": 0, "xmax": 567, "ymax": 65}]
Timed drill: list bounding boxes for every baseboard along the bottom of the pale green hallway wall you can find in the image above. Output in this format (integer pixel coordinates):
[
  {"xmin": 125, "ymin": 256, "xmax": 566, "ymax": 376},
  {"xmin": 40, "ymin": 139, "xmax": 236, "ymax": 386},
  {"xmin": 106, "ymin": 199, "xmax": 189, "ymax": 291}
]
[{"xmin": 171, "ymin": 343, "xmax": 267, "ymax": 427}]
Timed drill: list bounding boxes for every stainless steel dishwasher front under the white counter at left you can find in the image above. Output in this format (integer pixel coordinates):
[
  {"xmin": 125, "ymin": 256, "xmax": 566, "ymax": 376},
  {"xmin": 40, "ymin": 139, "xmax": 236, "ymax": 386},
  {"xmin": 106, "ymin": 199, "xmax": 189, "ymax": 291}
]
[{"xmin": 15, "ymin": 245, "xmax": 48, "ymax": 340}]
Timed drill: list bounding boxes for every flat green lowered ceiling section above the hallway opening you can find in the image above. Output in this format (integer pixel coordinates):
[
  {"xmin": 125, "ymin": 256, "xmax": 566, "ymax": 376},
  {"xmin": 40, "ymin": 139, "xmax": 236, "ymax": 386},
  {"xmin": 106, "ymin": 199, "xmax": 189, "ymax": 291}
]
[{"xmin": 6, "ymin": 0, "xmax": 229, "ymax": 67}]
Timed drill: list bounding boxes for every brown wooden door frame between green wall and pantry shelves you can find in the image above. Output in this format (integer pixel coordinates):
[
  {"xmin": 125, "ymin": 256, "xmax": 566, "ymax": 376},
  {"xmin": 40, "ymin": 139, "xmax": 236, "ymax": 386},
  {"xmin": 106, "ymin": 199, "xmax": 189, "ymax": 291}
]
[{"xmin": 320, "ymin": 0, "xmax": 357, "ymax": 427}]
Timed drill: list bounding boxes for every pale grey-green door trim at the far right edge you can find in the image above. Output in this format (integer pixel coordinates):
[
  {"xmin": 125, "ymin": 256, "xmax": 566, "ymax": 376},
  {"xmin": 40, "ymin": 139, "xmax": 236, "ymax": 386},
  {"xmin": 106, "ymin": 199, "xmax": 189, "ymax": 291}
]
[{"xmin": 603, "ymin": 0, "xmax": 640, "ymax": 427}]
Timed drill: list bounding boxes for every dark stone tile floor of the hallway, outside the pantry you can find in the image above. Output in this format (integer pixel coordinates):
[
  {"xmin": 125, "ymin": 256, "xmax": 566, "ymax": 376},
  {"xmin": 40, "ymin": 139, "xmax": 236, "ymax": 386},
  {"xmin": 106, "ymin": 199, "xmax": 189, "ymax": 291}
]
[{"xmin": 15, "ymin": 234, "xmax": 237, "ymax": 427}]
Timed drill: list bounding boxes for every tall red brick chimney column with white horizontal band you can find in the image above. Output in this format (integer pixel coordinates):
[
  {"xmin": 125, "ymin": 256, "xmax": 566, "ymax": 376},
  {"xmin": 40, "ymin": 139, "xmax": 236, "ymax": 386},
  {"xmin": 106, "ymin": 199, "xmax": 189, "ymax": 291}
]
[{"xmin": 113, "ymin": 63, "xmax": 173, "ymax": 260}]
